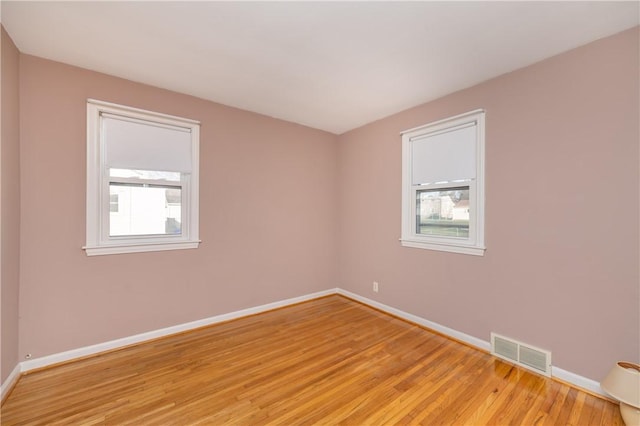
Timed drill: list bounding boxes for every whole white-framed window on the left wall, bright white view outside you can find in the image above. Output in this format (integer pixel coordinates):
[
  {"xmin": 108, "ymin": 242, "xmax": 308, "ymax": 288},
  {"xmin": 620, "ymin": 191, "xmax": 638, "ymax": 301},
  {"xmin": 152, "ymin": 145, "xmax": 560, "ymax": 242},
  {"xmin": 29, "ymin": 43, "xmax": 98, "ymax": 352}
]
[{"xmin": 84, "ymin": 100, "xmax": 200, "ymax": 256}]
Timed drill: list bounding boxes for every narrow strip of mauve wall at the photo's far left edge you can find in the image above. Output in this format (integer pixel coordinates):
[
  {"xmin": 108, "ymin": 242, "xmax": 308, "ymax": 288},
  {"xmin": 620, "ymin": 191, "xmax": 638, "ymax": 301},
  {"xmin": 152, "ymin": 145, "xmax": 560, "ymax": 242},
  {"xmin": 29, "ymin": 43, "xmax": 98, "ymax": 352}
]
[{"xmin": 0, "ymin": 27, "xmax": 20, "ymax": 382}]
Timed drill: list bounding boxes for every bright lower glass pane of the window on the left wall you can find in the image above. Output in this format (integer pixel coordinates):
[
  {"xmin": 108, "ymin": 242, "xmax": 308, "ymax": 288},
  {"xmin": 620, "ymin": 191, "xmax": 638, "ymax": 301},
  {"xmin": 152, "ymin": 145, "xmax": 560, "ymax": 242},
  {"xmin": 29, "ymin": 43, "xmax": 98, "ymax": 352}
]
[{"xmin": 109, "ymin": 182, "xmax": 182, "ymax": 237}]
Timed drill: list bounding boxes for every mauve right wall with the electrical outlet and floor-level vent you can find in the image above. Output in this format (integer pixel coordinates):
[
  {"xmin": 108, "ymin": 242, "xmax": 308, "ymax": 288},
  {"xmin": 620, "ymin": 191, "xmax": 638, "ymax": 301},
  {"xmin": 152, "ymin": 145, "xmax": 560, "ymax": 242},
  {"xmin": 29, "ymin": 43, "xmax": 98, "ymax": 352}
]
[{"xmin": 339, "ymin": 28, "xmax": 640, "ymax": 381}]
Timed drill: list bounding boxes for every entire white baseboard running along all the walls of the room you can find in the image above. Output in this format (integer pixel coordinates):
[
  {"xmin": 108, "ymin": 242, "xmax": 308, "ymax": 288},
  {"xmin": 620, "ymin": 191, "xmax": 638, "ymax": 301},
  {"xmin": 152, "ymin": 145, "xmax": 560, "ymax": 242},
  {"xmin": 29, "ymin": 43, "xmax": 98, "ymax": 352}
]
[{"xmin": 13, "ymin": 288, "xmax": 608, "ymax": 397}]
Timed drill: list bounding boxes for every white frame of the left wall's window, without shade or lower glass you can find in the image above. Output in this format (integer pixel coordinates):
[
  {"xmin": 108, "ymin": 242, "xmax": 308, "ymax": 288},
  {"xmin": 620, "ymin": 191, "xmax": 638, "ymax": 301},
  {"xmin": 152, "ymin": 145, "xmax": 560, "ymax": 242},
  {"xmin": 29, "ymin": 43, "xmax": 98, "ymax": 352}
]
[{"xmin": 83, "ymin": 99, "xmax": 200, "ymax": 256}]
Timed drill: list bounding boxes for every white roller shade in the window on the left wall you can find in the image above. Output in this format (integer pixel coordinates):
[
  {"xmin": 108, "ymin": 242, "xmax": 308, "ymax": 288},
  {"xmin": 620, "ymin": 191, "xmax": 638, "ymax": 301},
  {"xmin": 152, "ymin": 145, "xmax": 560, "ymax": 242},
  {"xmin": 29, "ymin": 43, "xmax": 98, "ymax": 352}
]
[{"xmin": 101, "ymin": 114, "xmax": 191, "ymax": 173}]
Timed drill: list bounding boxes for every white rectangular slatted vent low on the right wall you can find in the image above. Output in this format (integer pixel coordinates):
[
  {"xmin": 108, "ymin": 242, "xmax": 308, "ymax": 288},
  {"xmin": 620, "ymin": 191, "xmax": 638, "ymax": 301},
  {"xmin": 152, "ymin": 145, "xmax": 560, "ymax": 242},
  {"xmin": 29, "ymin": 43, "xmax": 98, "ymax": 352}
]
[{"xmin": 491, "ymin": 333, "xmax": 551, "ymax": 377}]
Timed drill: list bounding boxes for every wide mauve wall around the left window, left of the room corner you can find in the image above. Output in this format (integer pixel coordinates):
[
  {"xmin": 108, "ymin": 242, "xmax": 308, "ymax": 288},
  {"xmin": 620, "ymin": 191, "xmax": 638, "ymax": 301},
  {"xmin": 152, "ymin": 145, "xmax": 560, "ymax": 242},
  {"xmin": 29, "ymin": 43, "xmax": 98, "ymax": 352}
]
[{"xmin": 20, "ymin": 55, "xmax": 338, "ymax": 357}]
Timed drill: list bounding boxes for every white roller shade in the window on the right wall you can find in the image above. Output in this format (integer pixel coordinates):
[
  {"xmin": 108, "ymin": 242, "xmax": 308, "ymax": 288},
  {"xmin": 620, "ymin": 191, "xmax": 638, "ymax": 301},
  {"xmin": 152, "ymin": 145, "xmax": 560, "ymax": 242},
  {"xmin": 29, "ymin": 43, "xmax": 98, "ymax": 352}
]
[{"xmin": 411, "ymin": 123, "xmax": 476, "ymax": 185}]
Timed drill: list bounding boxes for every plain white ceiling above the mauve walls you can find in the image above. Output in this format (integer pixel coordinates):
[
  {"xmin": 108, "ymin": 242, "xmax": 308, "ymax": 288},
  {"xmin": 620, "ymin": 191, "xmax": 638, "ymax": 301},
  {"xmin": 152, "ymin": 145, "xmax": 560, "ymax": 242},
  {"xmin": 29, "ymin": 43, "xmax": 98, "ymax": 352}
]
[{"xmin": 1, "ymin": 0, "xmax": 640, "ymax": 134}]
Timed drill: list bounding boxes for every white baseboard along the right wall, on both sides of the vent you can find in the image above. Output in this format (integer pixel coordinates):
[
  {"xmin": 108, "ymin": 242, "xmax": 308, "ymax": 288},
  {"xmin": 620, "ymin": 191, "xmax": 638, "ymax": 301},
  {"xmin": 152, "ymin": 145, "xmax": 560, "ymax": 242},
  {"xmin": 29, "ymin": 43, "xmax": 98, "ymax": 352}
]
[{"xmin": 336, "ymin": 288, "xmax": 611, "ymax": 398}]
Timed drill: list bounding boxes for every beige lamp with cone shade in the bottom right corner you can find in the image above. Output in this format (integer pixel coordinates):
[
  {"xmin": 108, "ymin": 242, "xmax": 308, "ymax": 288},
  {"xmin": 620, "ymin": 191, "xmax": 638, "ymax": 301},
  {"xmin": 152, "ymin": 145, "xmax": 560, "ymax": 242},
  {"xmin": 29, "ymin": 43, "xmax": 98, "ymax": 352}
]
[{"xmin": 600, "ymin": 362, "xmax": 640, "ymax": 426}]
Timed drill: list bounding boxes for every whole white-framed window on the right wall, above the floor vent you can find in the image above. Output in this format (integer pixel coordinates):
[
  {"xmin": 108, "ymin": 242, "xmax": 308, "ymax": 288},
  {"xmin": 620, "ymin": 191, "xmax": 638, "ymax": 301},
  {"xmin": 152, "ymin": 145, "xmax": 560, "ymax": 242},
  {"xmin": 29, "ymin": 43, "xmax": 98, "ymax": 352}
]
[{"xmin": 401, "ymin": 110, "xmax": 485, "ymax": 256}]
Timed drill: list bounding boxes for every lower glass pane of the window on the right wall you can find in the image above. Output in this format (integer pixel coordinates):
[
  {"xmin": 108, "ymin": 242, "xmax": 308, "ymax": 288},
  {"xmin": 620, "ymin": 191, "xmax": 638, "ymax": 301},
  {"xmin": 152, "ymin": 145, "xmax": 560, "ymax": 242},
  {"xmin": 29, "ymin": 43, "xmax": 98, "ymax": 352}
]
[{"xmin": 416, "ymin": 186, "xmax": 469, "ymax": 238}]
